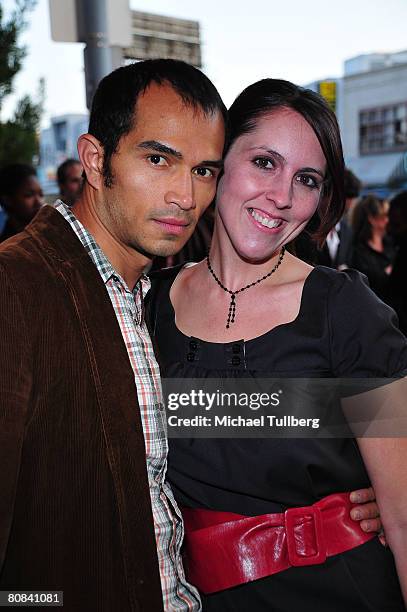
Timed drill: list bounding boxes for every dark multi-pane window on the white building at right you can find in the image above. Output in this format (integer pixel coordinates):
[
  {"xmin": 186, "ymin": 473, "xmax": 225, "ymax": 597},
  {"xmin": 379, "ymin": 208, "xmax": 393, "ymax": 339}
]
[{"xmin": 359, "ymin": 102, "xmax": 407, "ymax": 155}]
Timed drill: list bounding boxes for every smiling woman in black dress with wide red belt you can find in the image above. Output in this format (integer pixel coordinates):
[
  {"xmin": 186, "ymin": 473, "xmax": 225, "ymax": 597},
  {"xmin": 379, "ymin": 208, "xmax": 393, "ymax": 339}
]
[{"xmin": 150, "ymin": 79, "xmax": 407, "ymax": 612}]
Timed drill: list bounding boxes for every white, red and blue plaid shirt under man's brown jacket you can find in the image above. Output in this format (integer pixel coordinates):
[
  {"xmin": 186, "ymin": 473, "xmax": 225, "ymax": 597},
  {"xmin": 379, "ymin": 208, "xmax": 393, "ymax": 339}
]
[{"xmin": 55, "ymin": 200, "xmax": 201, "ymax": 612}]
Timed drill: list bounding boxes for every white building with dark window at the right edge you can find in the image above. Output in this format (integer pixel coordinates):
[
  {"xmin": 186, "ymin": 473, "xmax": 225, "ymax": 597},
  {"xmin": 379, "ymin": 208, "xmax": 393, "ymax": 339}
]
[{"xmin": 340, "ymin": 51, "xmax": 407, "ymax": 195}]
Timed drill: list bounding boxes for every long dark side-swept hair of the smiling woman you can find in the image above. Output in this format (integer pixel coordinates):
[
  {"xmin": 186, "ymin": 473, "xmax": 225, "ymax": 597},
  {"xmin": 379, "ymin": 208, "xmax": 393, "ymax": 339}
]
[{"xmin": 228, "ymin": 79, "xmax": 345, "ymax": 244}]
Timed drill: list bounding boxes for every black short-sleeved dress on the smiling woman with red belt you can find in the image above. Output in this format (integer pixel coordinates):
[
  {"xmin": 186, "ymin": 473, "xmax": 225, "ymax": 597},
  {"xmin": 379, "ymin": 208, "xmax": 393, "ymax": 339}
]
[{"xmin": 149, "ymin": 266, "xmax": 407, "ymax": 612}]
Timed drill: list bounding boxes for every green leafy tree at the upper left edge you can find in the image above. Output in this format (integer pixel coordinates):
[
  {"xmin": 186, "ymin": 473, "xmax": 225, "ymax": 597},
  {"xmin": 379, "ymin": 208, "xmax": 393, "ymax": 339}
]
[{"xmin": 0, "ymin": 0, "xmax": 44, "ymax": 165}]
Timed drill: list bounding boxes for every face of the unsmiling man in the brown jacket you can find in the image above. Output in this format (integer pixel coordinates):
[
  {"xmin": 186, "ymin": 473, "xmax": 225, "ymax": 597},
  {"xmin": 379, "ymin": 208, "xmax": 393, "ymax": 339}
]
[{"xmin": 97, "ymin": 84, "xmax": 224, "ymax": 258}]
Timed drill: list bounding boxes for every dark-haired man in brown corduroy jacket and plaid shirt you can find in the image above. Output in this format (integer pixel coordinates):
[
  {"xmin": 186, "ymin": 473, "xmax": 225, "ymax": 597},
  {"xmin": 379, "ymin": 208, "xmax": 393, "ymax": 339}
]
[{"xmin": 0, "ymin": 60, "xmax": 226, "ymax": 612}]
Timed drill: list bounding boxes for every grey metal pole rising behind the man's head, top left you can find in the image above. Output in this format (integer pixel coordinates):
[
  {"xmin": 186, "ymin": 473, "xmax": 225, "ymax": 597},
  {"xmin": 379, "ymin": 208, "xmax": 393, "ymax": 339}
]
[{"xmin": 77, "ymin": 0, "xmax": 113, "ymax": 108}]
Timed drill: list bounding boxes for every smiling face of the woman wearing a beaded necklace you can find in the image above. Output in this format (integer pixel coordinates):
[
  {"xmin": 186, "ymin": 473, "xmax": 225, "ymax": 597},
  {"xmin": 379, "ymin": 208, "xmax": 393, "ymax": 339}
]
[{"xmin": 217, "ymin": 108, "xmax": 326, "ymax": 261}]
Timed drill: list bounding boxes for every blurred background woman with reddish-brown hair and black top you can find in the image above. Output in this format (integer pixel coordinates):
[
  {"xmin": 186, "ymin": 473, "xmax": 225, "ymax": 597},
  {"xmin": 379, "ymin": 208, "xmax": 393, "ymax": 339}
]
[{"xmin": 352, "ymin": 195, "xmax": 395, "ymax": 299}]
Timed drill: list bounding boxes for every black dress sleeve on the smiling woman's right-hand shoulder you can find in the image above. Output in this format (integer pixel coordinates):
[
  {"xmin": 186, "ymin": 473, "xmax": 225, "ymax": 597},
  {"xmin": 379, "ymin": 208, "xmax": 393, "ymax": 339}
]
[{"xmin": 327, "ymin": 270, "xmax": 407, "ymax": 378}]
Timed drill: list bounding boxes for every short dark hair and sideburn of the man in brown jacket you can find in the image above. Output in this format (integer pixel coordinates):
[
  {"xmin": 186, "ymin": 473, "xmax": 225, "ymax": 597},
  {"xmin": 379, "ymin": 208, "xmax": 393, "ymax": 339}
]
[{"xmin": 88, "ymin": 59, "xmax": 227, "ymax": 187}]
